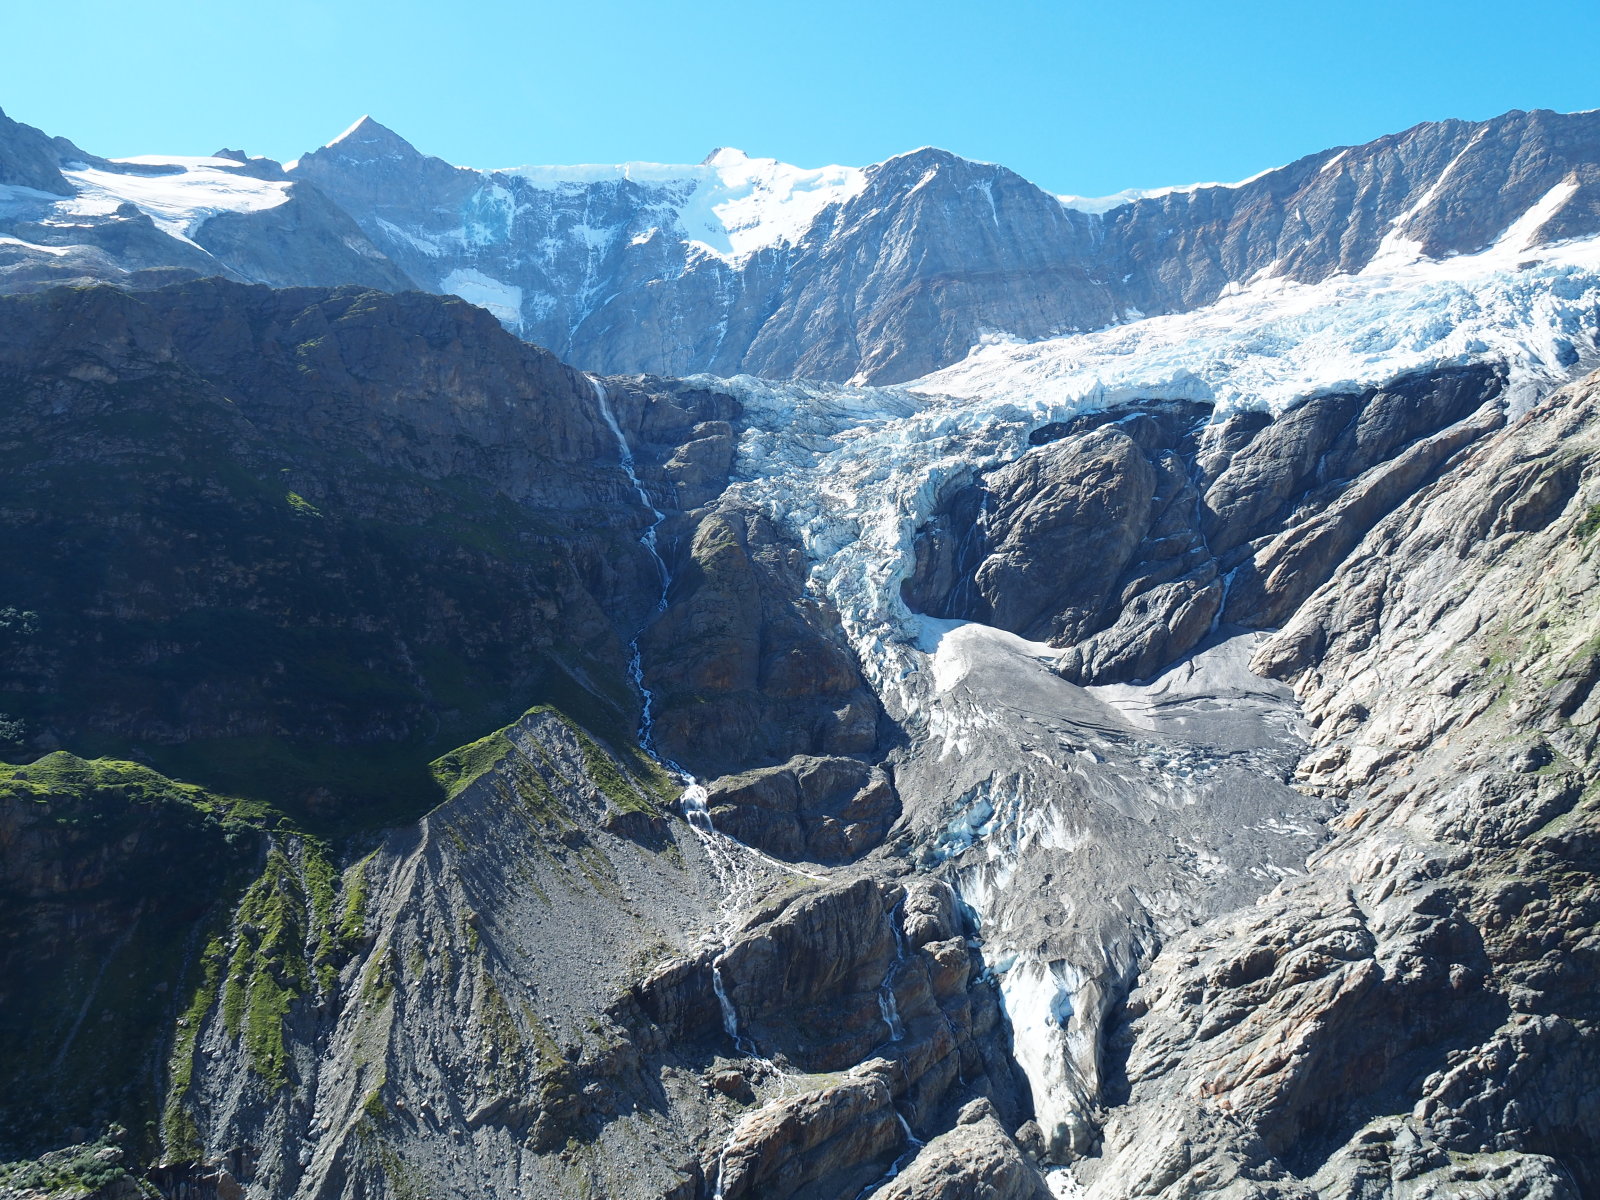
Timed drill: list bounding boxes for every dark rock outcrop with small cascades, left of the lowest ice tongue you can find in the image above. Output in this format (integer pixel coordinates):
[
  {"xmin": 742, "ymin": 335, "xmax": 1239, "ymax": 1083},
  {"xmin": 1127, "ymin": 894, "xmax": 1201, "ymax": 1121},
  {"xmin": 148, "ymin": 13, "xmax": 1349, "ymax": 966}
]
[{"xmin": 634, "ymin": 878, "xmax": 1030, "ymax": 1200}]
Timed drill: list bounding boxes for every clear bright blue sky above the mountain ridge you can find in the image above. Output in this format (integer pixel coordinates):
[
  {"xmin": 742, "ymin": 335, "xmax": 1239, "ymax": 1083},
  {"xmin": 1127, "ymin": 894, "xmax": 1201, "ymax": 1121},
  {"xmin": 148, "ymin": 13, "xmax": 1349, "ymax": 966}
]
[{"xmin": 0, "ymin": 0, "xmax": 1600, "ymax": 195}]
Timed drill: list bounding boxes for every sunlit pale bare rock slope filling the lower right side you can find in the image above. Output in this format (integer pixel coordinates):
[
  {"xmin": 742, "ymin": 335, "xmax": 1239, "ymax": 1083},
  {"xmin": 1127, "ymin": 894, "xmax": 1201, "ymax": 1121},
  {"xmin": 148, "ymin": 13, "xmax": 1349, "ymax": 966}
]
[{"xmin": 1078, "ymin": 376, "xmax": 1600, "ymax": 1200}]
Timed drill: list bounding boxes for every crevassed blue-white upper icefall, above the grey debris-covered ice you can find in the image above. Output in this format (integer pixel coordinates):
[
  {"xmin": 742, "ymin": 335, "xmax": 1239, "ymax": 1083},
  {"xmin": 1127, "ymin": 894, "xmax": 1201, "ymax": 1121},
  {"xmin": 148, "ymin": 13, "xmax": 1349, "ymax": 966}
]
[{"xmin": 704, "ymin": 224, "xmax": 1600, "ymax": 702}]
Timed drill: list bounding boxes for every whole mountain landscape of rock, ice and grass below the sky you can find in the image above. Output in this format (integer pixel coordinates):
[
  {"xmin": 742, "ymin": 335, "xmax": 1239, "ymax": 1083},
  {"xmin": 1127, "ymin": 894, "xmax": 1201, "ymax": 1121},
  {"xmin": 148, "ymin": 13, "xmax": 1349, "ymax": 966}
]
[{"xmin": 0, "ymin": 101, "xmax": 1600, "ymax": 1200}]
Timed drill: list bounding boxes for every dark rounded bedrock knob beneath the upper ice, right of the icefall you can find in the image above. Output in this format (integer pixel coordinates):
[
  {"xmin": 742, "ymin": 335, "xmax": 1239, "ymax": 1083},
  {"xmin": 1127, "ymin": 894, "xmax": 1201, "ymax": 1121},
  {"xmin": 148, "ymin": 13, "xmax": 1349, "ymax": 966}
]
[{"xmin": 906, "ymin": 366, "xmax": 1504, "ymax": 683}]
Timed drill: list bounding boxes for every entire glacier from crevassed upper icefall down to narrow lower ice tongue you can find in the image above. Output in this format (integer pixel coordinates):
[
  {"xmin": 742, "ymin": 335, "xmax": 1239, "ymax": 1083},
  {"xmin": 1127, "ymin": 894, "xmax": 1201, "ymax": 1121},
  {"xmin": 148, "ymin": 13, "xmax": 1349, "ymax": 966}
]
[{"xmin": 681, "ymin": 214, "xmax": 1600, "ymax": 1147}]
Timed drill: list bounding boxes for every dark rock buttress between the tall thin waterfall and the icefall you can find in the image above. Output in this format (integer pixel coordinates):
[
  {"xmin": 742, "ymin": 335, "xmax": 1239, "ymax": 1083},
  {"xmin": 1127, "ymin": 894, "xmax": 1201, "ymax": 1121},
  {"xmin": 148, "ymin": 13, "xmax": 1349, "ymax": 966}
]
[{"xmin": 592, "ymin": 376, "xmax": 893, "ymax": 790}]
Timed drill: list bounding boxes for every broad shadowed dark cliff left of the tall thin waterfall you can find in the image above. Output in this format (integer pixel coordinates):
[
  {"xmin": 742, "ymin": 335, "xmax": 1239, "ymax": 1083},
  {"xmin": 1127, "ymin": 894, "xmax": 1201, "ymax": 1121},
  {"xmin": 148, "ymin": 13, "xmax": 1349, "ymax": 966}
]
[{"xmin": 0, "ymin": 282, "xmax": 707, "ymax": 816}]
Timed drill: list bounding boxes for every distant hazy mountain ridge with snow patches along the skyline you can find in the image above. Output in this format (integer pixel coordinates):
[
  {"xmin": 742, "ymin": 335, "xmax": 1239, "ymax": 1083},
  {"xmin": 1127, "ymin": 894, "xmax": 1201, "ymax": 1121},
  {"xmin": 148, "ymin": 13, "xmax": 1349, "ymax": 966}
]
[{"xmin": 0, "ymin": 112, "xmax": 1600, "ymax": 382}]
